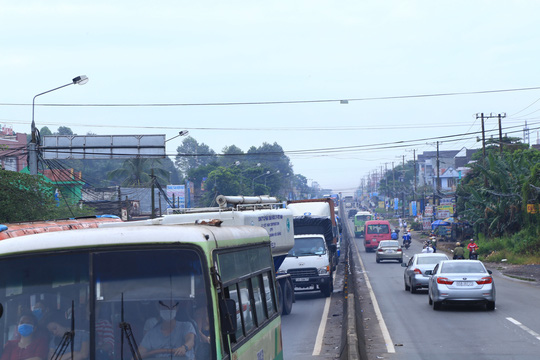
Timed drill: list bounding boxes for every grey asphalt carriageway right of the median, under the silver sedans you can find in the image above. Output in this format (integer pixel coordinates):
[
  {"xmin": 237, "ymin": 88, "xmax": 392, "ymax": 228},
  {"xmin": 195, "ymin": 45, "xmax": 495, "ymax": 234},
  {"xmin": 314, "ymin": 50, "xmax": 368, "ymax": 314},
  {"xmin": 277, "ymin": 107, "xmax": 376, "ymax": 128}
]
[{"xmin": 353, "ymin": 231, "xmax": 540, "ymax": 360}]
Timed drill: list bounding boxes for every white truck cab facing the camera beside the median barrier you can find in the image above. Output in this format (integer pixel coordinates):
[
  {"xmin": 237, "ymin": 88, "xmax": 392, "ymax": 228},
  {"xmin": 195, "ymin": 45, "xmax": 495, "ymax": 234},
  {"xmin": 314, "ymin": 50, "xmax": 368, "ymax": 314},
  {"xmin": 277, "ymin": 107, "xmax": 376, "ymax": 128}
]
[{"xmin": 279, "ymin": 234, "xmax": 334, "ymax": 297}]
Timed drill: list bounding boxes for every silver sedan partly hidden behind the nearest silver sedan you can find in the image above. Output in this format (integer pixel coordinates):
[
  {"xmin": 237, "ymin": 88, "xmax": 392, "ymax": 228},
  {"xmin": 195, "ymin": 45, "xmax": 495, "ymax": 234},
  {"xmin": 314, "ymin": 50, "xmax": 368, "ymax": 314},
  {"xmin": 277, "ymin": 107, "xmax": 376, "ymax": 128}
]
[{"xmin": 401, "ymin": 253, "xmax": 448, "ymax": 294}]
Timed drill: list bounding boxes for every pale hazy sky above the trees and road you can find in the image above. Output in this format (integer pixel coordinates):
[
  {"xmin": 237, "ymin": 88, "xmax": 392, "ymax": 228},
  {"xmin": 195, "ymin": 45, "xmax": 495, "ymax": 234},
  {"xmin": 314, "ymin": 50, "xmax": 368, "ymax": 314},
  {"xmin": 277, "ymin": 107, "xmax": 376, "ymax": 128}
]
[{"xmin": 0, "ymin": 0, "xmax": 540, "ymax": 192}]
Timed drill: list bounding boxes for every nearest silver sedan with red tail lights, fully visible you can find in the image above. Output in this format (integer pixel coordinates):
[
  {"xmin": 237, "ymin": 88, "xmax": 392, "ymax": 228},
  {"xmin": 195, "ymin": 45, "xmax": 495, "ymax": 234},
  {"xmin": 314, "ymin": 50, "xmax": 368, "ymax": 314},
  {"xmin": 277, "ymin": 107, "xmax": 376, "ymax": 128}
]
[{"xmin": 425, "ymin": 260, "xmax": 495, "ymax": 310}]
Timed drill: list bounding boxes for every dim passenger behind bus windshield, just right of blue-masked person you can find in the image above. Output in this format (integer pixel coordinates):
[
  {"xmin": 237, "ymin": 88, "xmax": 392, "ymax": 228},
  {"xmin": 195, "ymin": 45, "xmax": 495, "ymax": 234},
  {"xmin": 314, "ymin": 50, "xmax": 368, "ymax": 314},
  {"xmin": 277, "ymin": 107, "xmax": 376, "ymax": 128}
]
[{"xmin": 47, "ymin": 312, "xmax": 90, "ymax": 360}]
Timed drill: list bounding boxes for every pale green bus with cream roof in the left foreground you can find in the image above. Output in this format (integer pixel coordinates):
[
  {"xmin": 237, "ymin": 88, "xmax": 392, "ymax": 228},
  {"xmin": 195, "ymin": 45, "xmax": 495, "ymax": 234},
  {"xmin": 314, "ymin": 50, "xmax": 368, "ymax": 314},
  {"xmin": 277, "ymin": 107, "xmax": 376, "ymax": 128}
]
[{"xmin": 0, "ymin": 222, "xmax": 283, "ymax": 360}]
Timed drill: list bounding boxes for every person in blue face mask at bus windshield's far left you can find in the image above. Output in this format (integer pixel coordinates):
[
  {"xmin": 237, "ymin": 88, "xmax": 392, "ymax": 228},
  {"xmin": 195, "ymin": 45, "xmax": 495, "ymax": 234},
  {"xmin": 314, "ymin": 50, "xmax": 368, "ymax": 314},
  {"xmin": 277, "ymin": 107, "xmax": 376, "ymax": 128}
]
[{"xmin": 1, "ymin": 313, "xmax": 48, "ymax": 360}]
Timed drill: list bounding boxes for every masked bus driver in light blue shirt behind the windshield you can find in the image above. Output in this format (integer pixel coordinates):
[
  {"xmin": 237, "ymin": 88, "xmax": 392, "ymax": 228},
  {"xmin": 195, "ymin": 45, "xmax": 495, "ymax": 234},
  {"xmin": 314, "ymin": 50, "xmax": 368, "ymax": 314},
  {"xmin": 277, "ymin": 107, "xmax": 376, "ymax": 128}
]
[{"xmin": 139, "ymin": 300, "xmax": 196, "ymax": 360}]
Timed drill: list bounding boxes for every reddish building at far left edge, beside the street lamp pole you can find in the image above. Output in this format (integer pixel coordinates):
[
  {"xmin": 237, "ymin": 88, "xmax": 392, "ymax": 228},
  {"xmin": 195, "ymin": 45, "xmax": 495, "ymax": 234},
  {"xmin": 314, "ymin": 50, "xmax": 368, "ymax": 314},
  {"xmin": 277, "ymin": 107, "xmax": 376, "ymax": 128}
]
[{"xmin": 0, "ymin": 125, "xmax": 27, "ymax": 171}]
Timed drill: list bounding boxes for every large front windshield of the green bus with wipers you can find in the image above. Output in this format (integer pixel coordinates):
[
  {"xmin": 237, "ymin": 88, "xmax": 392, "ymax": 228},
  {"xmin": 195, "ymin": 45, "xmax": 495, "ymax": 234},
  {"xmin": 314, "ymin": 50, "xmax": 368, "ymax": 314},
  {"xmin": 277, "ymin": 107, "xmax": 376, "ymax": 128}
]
[{"xmin": 0, "ymin": 248, "xmax": 209, "ymax": 360}]
